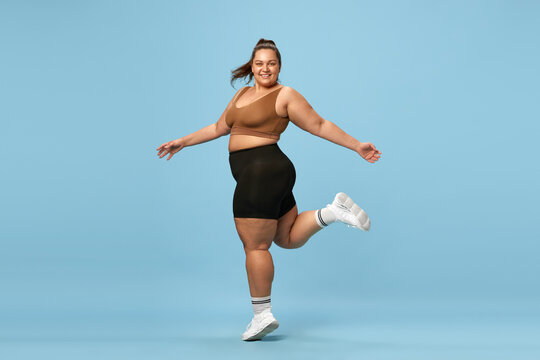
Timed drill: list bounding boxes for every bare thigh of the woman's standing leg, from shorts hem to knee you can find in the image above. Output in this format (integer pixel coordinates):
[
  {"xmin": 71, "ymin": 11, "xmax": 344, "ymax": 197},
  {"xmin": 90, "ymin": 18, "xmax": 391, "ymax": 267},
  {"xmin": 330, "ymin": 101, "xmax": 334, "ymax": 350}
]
[{"xmin": 234, "ymin": 218, "xmax": 278, "ymax": 250}]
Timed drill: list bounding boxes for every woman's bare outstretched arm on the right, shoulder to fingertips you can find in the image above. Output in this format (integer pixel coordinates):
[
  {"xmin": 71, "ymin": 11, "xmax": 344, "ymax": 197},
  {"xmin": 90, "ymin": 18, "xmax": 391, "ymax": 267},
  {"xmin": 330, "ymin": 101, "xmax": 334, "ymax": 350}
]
[{"xmin": 287, "ymin": 87, "xmax": 381, "ymax": 163}]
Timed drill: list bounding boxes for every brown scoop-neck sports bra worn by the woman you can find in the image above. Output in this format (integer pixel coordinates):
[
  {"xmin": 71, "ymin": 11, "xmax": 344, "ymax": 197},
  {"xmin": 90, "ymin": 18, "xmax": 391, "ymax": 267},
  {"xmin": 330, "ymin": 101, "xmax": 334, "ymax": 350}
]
[{"xmin": 225, "ymin": 86, "xmax": 289, "ymax": 140}]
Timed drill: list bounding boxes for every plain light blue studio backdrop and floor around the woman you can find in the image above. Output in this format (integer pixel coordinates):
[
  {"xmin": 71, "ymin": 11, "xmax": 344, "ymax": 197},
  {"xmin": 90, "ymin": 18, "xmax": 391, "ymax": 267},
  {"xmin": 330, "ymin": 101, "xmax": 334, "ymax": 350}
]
[{"xmin": 0, "ymin": 0, "xmax": 540, "ymax": 360}]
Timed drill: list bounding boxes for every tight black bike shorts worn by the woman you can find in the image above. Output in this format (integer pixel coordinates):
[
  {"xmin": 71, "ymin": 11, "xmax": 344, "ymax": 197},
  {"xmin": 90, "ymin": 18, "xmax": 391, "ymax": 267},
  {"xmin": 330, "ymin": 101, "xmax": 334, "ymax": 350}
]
[{"xmin": 229, "ymin": 144, "xmax": 296, "ymax": 219}]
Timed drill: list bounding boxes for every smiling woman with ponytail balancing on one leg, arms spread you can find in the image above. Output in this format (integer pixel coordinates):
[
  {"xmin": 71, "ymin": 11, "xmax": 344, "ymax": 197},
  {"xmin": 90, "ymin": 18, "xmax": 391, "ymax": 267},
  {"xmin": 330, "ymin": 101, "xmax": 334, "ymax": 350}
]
[{"xmin": 157, "ymin": 39, "xmax": 381, "ymax": 341}]
